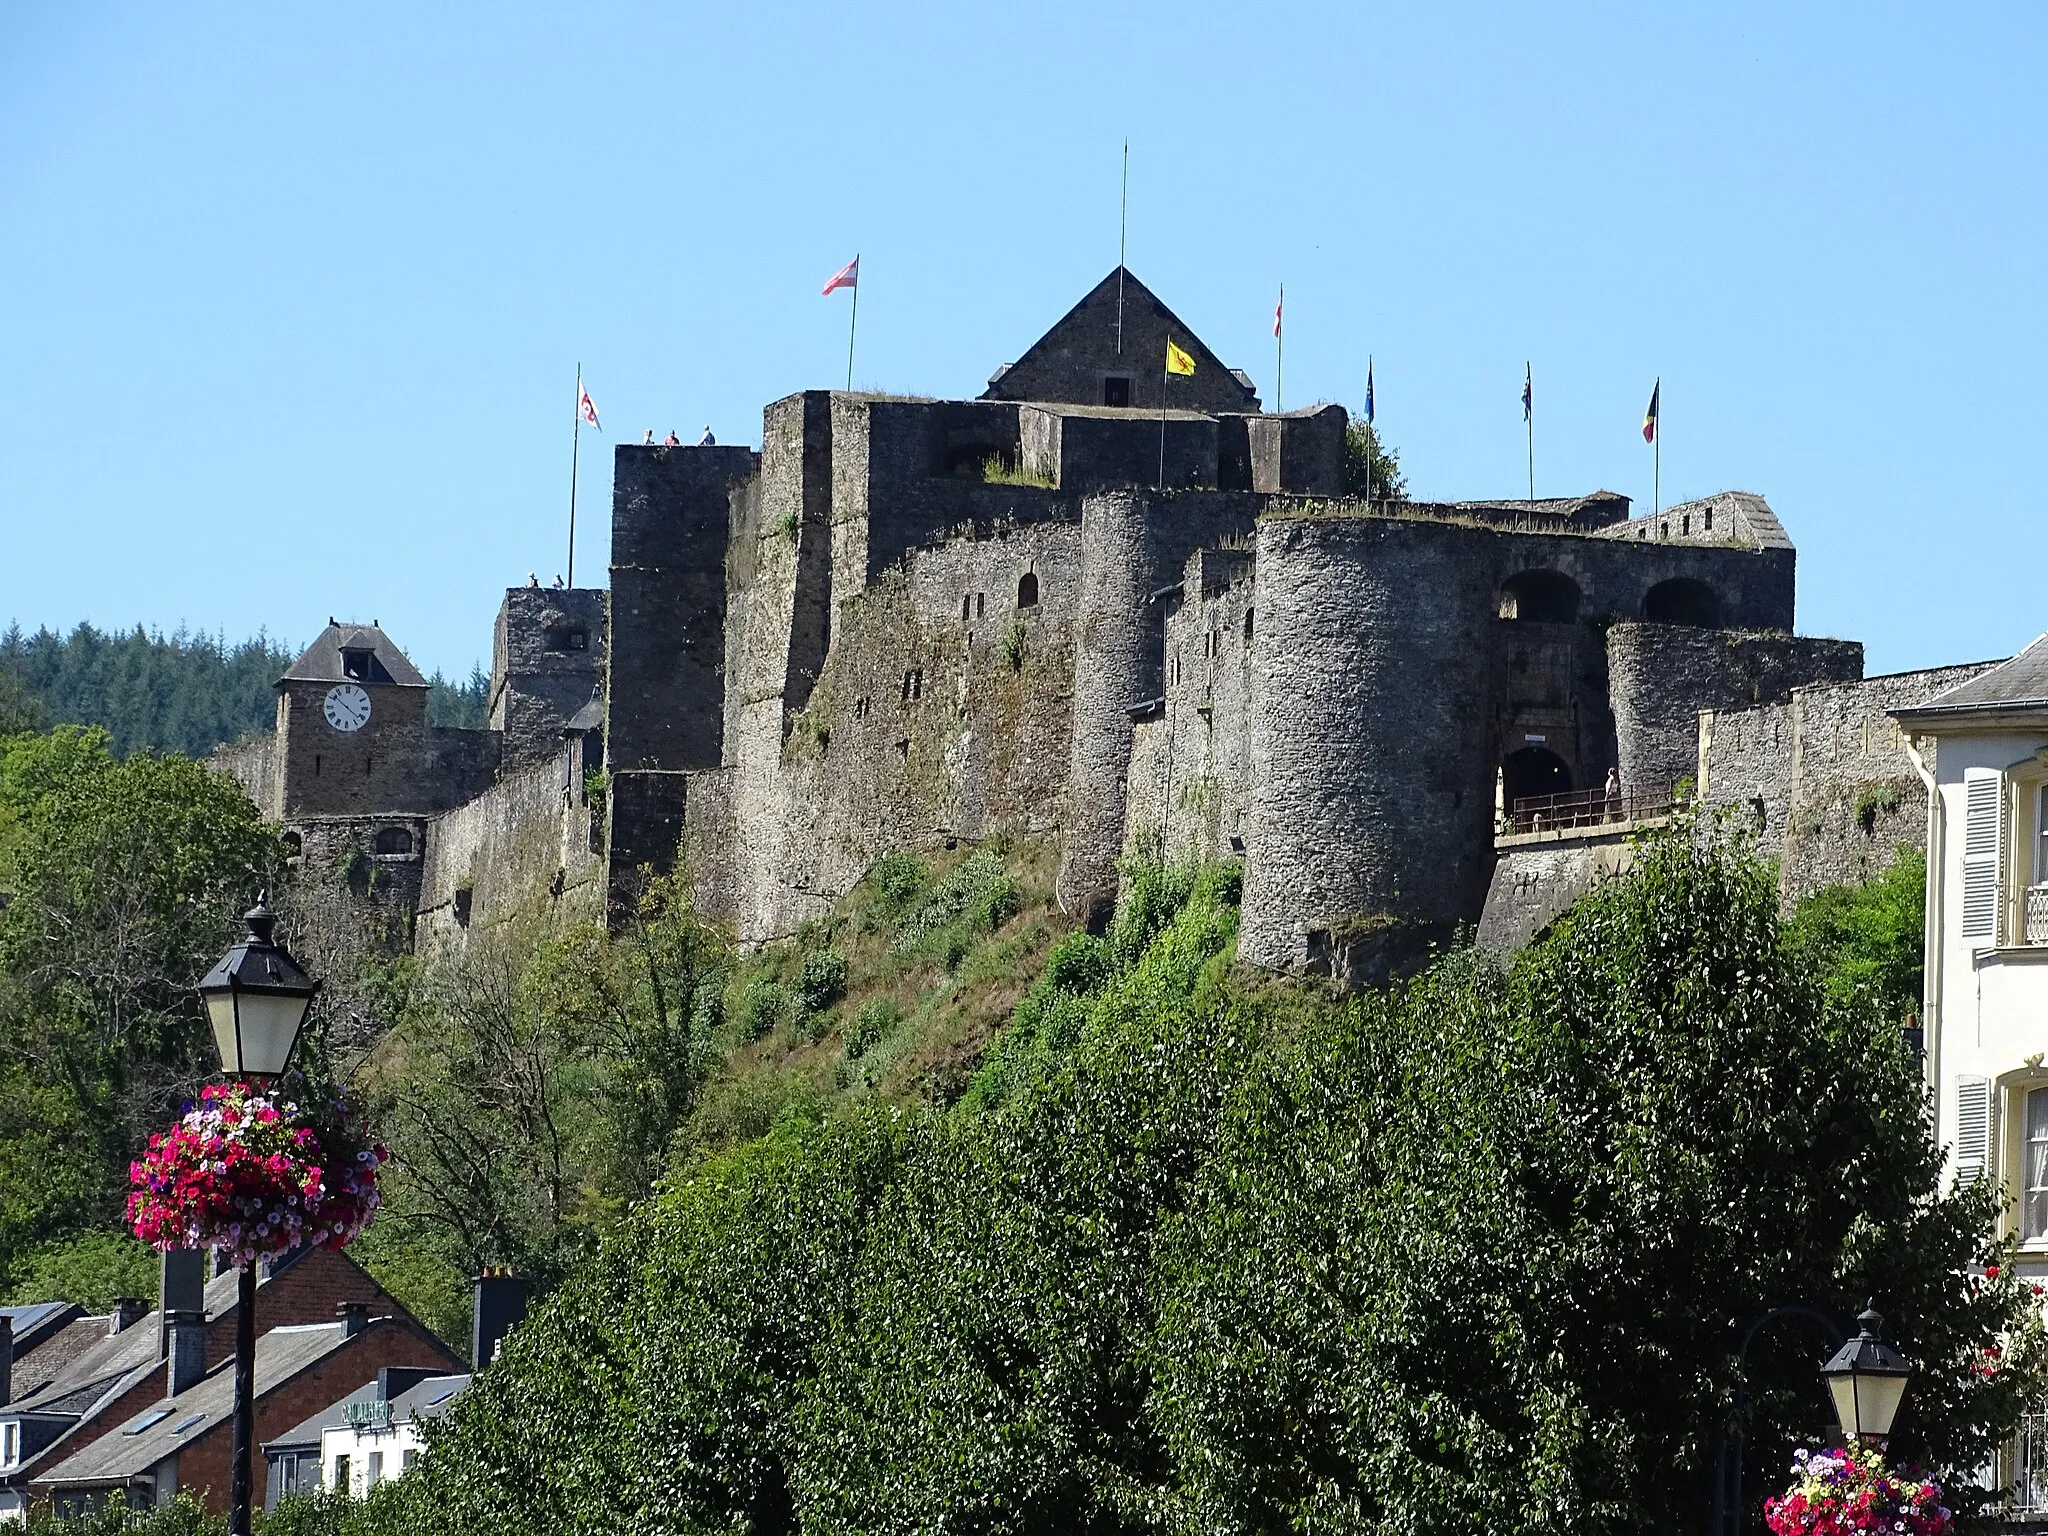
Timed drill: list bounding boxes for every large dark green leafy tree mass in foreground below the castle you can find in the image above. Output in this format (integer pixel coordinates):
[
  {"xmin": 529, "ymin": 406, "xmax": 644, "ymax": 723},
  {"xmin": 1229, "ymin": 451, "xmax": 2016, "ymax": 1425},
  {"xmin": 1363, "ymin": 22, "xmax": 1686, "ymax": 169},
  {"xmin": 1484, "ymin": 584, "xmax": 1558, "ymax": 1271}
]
[{"xmin": 352, "ymin": 834, "xmax": 2042, "ymax": 1536}]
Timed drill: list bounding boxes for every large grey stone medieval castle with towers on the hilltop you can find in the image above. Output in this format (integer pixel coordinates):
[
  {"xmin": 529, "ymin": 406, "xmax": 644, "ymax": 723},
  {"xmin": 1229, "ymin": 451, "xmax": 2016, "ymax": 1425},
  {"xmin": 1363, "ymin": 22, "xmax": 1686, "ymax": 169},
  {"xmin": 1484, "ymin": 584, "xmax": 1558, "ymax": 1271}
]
[{"xmin": 223, "ymin": 272, "xmax": 1925, "ymax": 987}]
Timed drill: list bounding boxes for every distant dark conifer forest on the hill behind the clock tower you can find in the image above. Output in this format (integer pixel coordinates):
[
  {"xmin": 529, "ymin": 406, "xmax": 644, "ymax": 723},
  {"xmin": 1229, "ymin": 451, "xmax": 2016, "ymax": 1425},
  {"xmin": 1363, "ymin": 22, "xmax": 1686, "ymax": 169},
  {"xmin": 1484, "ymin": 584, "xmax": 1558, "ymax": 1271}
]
[{"xmin": 0, "ymin": 625, "xmax": 489, "ymax": 758}]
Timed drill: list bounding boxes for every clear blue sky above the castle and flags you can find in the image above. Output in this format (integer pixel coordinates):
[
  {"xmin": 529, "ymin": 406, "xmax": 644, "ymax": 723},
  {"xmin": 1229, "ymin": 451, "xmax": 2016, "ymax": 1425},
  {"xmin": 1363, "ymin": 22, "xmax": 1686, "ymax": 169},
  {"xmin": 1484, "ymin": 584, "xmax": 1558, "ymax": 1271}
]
[{"xmin": 0, "ymin": 0, "xmax": 2048, "ymax": 672}]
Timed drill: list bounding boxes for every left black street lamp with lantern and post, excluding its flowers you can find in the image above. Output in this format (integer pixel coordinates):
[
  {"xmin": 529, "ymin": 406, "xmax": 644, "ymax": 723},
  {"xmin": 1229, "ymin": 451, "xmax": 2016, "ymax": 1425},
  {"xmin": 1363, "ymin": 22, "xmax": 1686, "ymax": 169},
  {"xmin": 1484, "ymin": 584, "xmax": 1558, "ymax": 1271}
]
[{"xmin": 199, "ymin": 893, "xmax": 319, "ymax": 1536}]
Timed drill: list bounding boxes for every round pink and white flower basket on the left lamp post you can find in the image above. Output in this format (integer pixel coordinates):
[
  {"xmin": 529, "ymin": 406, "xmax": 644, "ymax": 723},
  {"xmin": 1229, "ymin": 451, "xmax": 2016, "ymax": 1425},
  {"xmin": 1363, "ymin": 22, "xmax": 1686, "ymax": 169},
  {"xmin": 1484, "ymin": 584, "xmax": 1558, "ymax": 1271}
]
[{"xmin": 127, "ymin": 1083, "xmax": 389, "ymax": 1266}]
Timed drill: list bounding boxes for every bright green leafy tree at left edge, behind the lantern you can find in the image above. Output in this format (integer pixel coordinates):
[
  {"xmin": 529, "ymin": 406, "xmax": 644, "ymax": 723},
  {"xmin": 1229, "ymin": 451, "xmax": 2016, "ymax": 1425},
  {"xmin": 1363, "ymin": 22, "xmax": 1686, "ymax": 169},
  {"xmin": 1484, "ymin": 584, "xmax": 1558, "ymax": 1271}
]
[{"xmin": 0, "ymin": 727, "xmax": 283, "ymax": 1284}]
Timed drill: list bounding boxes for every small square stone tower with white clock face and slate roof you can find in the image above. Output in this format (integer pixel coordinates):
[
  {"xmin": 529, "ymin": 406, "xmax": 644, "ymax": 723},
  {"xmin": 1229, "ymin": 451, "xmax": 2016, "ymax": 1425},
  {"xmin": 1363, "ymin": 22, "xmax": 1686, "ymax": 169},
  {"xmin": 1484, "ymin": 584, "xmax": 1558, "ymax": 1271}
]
[{"xmin": 274, "ymin": 621, "xmax": 434, "ymax": 821}]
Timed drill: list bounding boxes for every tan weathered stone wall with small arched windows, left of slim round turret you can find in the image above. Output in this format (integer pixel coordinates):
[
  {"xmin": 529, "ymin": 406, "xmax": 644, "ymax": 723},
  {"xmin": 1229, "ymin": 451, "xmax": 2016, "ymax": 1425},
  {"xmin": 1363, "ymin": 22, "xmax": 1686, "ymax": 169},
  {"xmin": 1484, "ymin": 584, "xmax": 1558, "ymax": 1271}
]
[{"xmin": 704, "ymin": 524, "xmax": 1079, "ymax": 940}]
